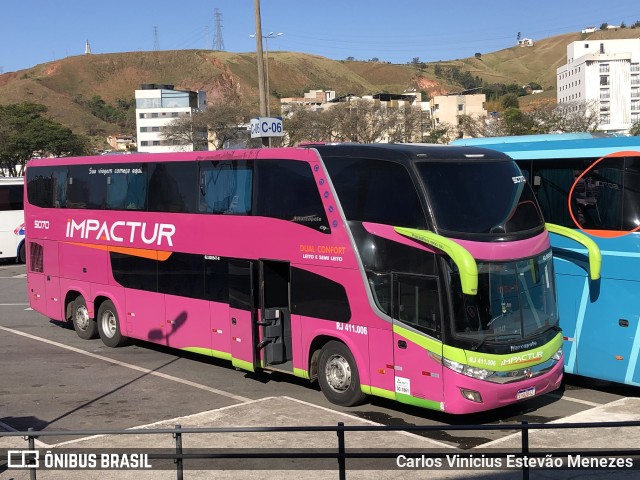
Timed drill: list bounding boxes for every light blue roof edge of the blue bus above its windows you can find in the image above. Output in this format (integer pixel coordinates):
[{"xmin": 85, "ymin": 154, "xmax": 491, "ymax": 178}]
[{"xmin": 452, "ymin": 133, "xmax": 640, "ymax": 160}]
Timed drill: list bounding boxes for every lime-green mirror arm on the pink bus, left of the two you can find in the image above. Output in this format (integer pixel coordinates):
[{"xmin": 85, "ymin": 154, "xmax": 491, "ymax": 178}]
[{"xmin": 393, "ymin": 227, "xmax": 478, "ymax": 295}]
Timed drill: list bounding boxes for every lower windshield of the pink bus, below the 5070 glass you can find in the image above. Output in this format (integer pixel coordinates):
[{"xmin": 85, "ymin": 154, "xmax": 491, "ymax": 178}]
[{"xmin": 450, "ymin": 250, "xmax": 558, "ymax": 345}]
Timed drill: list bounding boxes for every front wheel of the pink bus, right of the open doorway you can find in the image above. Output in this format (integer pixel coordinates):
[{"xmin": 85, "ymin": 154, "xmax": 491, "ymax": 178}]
[{"xmin": 318, "ymin": 341, "xmax": 367, "ymax": 407}]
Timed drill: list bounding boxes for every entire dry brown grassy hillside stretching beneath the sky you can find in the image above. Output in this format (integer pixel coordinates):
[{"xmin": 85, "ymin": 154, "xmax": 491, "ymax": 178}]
[{"xmin": 0, "ymin": 28, "xmax": 640, "ymax": 135}]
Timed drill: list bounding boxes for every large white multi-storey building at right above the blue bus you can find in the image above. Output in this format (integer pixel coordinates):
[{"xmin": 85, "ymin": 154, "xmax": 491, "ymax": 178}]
[{"xmin": 556, "ymin": 38, "xmax": 640, "ymax": 133}]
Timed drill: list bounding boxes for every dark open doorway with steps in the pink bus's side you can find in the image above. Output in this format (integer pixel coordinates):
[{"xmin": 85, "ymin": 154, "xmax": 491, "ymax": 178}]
[{"xmin": 257, "ymin": 260, "xmax": 293, "ymax": 372}]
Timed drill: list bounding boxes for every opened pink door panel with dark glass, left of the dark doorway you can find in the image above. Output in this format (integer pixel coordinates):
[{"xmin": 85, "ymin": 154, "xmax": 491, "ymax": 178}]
[{"xmin": 229, "ymin": 260, "xmax": 257, "ymax": 372}]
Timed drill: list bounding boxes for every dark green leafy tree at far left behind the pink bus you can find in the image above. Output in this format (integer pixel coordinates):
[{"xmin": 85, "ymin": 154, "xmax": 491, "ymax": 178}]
[{"xmin": 0, "ymin": 102, "xmax": 88, "ymax": 176}]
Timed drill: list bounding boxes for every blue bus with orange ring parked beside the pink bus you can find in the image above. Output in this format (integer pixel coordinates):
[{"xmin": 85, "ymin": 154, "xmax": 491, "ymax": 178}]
[{"xmin": 453, "ymin": 133, "xmax": 640, "ymax": 385}]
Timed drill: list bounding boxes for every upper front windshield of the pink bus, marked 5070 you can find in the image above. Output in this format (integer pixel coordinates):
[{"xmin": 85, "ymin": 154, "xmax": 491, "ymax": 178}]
[{"xmin": 416, "ymin": 159, "xmax": 543, "ymax": 234}]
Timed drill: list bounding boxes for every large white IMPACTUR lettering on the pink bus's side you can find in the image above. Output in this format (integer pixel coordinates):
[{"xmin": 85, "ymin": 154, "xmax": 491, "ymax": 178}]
[{"xmin": 67, "ymin": 218, "xmax": 176, "ymax": 247}]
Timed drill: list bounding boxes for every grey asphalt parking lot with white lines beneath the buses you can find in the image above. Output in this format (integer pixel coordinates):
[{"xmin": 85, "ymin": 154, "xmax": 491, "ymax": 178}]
[{"xmin": 0, "ymin": 262, "xmax": 640, "ymax": 478}]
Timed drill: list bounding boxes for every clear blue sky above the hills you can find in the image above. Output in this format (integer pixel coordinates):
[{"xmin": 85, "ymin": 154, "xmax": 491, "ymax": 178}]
[{"xmin": 0, "ymin": 0, "xmax": 640, "ymax": 73}]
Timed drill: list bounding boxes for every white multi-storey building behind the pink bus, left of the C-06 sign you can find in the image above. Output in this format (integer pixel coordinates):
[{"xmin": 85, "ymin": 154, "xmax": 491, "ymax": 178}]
[{"xmin": 136, "ymin": 83, "xmax": 207, "ymax": 153}]
